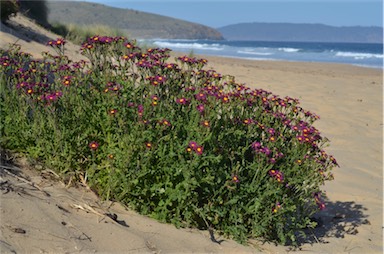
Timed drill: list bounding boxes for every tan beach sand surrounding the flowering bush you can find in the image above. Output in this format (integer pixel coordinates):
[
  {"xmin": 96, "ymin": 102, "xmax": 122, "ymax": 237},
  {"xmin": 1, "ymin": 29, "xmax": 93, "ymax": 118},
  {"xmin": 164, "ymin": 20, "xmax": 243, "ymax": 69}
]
[{"xmin": 0, "ymin": 14, "xmax": 383, "ymax": 253}]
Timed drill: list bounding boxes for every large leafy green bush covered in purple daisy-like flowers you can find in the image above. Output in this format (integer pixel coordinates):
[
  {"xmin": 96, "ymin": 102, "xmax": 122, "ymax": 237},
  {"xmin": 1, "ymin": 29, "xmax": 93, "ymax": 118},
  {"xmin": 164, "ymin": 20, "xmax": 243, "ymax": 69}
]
[{"xmin": 0, "ymin": 36, "xmax": 337, "ymax": 244}]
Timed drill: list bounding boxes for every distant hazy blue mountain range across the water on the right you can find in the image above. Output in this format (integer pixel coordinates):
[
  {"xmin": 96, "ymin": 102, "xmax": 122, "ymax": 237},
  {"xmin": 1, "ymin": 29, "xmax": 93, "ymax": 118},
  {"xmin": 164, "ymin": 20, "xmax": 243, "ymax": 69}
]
[{"xmin": 217, "ymin": 22, "xmax": 383, "ymax": 43}]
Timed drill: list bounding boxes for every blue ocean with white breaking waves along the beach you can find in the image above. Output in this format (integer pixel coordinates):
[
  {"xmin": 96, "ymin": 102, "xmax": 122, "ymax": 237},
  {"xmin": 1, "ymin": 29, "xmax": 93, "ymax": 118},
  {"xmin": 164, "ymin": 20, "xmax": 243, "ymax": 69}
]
[{"xmin": 144, "ymin": 39, "xmax": 383, "ymax": 69}]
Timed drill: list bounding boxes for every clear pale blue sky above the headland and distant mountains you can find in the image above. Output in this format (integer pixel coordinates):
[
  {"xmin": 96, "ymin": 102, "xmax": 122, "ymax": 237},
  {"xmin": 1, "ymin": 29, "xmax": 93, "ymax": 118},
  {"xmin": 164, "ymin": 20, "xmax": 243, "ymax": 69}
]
[{"xmin": 76, "ymin": 0, "xmax": 383, "ymax": 28}]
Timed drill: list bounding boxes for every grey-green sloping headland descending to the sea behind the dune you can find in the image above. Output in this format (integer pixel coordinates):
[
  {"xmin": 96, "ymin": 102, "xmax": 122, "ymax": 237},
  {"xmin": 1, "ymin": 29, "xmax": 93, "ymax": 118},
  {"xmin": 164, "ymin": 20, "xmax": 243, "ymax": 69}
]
[{"xmin": 47, "ymin": 1, "xmax": 223, "ymax": 40}]
